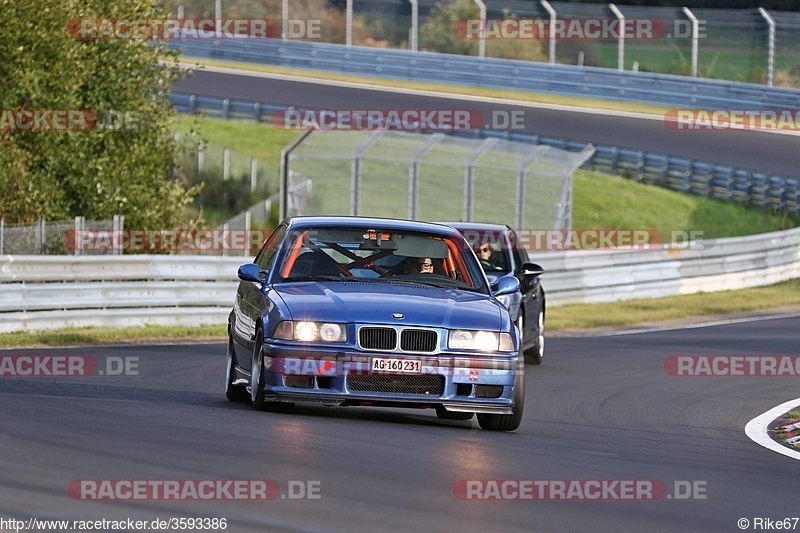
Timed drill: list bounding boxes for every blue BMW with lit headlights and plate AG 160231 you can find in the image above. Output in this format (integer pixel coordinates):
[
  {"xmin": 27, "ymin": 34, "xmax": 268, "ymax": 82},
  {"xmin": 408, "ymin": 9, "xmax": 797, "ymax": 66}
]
[{"xmin": 226, "ymin": 217, "xmax": 525, "ymax": 431}]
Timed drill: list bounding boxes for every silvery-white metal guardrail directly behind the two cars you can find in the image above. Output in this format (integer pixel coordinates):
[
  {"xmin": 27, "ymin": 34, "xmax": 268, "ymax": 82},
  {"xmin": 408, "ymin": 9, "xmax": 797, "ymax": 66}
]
[{"xmin": 0, "ymin": 228, "xmax": 800, "ymax": 333}]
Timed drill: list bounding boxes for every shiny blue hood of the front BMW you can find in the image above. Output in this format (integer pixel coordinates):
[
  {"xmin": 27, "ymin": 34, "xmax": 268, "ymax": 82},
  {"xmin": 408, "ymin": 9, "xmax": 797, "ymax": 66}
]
[{"xmin": 275, "ymin": 281, "xmax": 504, "ymax": 331}]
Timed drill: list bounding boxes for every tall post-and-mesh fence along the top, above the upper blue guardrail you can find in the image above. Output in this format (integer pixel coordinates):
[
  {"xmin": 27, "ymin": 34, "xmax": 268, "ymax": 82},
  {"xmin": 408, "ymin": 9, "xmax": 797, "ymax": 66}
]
[{"xmin": 169, "ymin": 0, "xmax": 800, "ymax": 87}]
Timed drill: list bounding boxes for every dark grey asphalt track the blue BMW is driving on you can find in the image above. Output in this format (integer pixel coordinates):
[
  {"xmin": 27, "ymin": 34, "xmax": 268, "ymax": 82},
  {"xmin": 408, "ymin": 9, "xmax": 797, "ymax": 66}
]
[{"xmin": 0, "ymin": 317, "xmax": 800, "ymax": 532}]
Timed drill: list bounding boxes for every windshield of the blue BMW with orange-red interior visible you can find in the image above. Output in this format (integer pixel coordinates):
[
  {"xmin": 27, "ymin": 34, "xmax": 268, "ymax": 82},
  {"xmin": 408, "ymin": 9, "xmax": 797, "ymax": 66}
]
[{"xmin": 277, "ymin": 227, "xmax": 487, "ymax": 292}]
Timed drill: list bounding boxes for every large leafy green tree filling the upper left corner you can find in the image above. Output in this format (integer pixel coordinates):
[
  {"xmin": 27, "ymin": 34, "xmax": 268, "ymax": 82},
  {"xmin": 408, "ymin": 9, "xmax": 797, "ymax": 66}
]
[{"xmin": 0, "ymin": 0, "xmax": 194, "ymax": 229}]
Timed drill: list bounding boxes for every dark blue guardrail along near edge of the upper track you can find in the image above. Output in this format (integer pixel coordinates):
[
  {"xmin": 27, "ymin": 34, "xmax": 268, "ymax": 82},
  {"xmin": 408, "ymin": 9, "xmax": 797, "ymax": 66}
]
[{"xmin": 170, "ymin": 93, "xmax": 800, "ymax": 215}]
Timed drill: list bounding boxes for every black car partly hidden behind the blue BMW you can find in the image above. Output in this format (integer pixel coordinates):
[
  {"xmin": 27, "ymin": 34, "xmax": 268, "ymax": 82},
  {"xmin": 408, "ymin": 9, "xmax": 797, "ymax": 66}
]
[{"xmin": 445, "ymin": 222, "xmax": 546, "ymax": 365}]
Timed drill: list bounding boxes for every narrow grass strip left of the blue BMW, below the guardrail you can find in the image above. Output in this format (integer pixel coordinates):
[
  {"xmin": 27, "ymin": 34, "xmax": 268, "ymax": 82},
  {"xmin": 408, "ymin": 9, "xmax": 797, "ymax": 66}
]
[{"xmin": 0, "ymin": 325, "xmax": 226, "ymax": 348}]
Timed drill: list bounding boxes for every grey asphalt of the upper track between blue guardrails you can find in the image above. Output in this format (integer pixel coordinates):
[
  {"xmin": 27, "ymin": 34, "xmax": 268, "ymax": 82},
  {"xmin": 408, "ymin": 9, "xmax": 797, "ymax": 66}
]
[{"xmin": 174, "ymin": 70, "xmax": 800, "ymax": 177}]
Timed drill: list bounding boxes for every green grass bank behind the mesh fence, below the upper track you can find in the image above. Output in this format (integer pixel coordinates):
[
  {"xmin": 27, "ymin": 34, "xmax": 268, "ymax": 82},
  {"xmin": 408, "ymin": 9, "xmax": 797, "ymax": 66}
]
[{"xmin": 179, "ymin": 117, "xmax": 800, "ymax": 238}]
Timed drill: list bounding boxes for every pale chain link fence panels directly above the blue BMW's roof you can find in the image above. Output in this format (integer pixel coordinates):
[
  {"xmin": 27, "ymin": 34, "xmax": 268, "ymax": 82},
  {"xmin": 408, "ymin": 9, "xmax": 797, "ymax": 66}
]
[{"xmin": 283, "ymin": 130, "xmax": 594, "ymax": 229}]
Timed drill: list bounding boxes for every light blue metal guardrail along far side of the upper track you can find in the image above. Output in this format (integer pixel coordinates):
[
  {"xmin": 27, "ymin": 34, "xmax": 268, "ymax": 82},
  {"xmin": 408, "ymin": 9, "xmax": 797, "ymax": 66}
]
[{"xmin": 170, "ymin": 39, "xmax": 800, "ymax": 110}]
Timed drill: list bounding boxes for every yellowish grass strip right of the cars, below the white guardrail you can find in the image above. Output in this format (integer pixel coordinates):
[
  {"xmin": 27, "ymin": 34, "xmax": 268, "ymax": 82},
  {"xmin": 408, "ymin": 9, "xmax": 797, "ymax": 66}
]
[{"xmin": 545, "ymin": 279, "xmax": 800, "ymax": 332}]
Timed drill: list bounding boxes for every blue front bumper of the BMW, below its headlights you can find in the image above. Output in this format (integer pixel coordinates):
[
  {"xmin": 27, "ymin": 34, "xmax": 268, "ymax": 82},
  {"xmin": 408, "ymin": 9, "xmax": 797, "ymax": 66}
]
[{"xmin": 256, "ymin": 342, "xmax": 523, "ymax": 414}]
